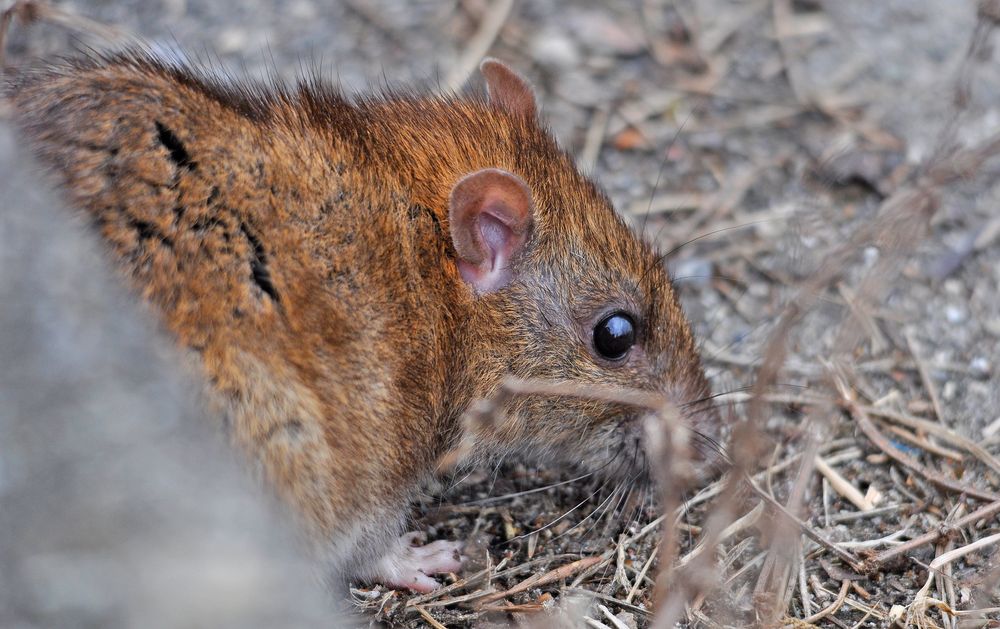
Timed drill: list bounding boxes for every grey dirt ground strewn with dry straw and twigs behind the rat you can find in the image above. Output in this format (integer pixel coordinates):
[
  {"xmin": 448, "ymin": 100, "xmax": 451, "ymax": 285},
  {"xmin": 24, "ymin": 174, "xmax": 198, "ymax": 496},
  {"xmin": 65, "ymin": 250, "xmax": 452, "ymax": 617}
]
[{"xmin": 1, "ymin": 0, "xmax": 1000, "ymax": 629}]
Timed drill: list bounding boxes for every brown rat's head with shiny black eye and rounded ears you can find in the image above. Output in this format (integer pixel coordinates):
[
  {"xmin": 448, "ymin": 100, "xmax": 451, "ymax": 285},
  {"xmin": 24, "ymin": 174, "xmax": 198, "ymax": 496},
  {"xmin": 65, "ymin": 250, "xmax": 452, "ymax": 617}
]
[{"xmin": 449, "ymin": 60, "xmax": 718, "ymax": 480}]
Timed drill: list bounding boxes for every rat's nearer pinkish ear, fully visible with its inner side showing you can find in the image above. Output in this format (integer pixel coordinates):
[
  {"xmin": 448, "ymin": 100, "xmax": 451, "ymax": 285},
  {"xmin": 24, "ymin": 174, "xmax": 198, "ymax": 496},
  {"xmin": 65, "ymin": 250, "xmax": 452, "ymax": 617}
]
[{"xmin": 448, "ymin": 168, "xmax": 534, "ymax": 295}]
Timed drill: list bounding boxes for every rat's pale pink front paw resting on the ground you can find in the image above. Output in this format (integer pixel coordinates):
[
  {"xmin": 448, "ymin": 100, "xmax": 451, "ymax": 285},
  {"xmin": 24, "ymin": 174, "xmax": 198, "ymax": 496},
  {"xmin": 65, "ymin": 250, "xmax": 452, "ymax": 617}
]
[{"xmin": 375, "ymin": 533, "xmax": 465, "ymax": 593}]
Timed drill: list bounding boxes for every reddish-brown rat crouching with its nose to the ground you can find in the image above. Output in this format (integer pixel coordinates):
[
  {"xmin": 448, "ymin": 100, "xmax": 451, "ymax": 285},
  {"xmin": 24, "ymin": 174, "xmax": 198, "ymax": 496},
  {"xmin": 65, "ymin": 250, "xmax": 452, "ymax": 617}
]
[{"xmin": 7, "ymin": 49, "xmax": 717, "ymax": 592}]
